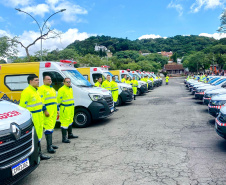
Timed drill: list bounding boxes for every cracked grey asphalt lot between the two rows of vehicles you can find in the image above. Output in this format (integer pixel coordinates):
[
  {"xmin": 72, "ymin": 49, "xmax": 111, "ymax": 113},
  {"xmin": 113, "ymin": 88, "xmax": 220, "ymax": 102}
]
[{"xmin": 19, "ymin": 78, "xmax": 226, "ymax": 185}]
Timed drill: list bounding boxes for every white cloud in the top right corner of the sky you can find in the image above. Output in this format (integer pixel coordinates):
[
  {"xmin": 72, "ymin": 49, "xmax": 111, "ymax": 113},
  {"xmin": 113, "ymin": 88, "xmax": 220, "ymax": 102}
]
[{"xmin": 190, "ymin": 0, "xmax": 225, "ymax": 13}]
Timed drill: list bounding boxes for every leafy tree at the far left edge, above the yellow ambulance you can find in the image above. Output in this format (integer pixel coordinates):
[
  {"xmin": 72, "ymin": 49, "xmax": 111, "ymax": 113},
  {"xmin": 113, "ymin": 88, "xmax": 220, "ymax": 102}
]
[{"xmin": 0, "ymin": 36, "xmax": 18, "ymax": 58}]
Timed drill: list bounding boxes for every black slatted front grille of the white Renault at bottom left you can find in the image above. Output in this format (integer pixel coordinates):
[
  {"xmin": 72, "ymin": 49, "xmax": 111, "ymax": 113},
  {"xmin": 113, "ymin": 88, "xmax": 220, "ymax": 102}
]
[{"xmin": 0, "ymin": 125, "xmax": 33, "ymax": 167}]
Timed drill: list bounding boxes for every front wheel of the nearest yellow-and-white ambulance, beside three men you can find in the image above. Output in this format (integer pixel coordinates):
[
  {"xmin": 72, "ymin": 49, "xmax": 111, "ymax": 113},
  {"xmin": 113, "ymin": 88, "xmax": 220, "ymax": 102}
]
[{"xmin": 74, "ymin": 108, "xmax": 91, "ymax": 128}]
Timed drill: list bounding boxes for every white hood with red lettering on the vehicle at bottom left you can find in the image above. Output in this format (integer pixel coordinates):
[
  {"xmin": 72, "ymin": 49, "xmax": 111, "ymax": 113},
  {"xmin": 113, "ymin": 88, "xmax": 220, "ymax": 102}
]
[{"xmin": 0, "ymin": 100, "xmax": 31, "ymax": 130}]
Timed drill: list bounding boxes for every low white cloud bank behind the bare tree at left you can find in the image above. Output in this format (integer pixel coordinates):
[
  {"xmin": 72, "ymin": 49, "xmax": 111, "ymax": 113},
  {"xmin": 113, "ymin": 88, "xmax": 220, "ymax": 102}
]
[{"xmin": 0, "ymin": 28, "xmax": 96, "ymax": 56}]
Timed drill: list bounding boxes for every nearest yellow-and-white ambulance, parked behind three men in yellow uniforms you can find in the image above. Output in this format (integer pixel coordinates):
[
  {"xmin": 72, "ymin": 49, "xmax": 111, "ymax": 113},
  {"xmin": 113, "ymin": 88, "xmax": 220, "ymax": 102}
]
[{"xmin": 0, "ymin": 60, "xmax": 114, "ymax": 127}]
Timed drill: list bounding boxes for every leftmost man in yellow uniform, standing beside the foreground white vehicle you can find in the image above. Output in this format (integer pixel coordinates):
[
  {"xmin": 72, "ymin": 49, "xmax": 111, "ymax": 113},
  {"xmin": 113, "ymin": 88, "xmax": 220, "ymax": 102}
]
[{"xmin": 19, "ymin": 74, "xmax": 50, "ymax": 160}]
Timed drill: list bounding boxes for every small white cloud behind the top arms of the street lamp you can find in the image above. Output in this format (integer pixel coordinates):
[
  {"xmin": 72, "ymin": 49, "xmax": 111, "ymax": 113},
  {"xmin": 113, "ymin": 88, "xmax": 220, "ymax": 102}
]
[{"xmin": 21, "ymin": 4, "xmax": 50, "ymax": 17}]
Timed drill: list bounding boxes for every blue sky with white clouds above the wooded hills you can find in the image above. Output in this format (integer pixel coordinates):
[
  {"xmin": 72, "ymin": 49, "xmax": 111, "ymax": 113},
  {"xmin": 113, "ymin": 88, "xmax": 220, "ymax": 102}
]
[{"xmin": 0, "ymin": 0, "xmax": 226, "ymax": 55}]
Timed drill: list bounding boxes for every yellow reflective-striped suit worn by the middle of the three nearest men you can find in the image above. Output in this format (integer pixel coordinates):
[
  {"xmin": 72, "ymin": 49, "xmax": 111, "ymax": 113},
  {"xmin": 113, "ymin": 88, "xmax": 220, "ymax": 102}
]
[{"xmin": 38, "ymin": 85, "xmax": 57, "ymax": 134}]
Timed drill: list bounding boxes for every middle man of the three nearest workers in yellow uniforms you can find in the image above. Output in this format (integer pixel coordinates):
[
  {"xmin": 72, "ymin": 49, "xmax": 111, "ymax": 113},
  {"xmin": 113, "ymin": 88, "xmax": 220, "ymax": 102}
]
[{"xmin": 38, "ymin": 75, "xmax": 58, "ymax": 153}]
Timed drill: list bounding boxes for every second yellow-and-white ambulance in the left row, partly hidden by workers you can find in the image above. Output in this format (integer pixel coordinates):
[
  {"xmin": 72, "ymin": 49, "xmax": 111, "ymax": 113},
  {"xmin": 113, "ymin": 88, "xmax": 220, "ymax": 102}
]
[{"xmin": 77, "ymin": 66, "xmax": 133, "ymax": 106}]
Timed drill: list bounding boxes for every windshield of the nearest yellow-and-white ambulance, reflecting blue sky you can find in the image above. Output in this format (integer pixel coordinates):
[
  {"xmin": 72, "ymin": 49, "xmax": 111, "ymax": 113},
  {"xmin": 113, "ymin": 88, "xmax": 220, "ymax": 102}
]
[{"xmin": 62, "ymin": 70, "xmax": 92, "ymax": 87}]
